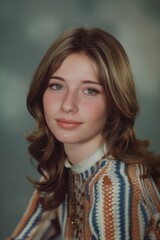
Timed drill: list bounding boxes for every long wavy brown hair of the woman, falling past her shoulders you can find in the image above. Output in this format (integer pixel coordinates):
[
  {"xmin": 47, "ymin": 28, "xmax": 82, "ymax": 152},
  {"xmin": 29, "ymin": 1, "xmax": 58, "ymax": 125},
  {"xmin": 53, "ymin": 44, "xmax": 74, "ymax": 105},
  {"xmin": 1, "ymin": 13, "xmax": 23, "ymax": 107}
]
[{"xmin": 27, "ymin": 28, "xmax": 160, "ymax": 209}]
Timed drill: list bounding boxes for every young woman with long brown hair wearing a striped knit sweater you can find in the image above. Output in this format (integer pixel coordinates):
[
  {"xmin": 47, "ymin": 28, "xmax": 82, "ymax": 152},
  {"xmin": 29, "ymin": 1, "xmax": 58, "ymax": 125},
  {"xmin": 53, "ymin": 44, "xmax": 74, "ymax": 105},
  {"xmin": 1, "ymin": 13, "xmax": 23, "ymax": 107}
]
[{"xmin": 9, "ymin": 28, "xmax": 160, "ymax": 240}]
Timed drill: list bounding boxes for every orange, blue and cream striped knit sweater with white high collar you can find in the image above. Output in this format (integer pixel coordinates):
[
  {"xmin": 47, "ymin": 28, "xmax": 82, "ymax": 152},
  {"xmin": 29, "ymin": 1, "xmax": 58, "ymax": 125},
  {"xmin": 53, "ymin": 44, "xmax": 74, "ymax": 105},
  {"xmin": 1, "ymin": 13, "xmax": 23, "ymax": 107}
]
[{"xmin": 8, "ymin": 149, "xmax": 160, "ymax": 240}]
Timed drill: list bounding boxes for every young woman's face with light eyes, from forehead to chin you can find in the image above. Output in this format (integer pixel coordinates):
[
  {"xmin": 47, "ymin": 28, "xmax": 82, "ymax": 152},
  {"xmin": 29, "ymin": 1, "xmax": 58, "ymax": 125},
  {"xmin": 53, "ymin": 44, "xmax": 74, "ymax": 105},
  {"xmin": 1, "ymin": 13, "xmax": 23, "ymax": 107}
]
[{"xmin": 43, "ymin": 53, "xmax": 107, "ymax": 147}]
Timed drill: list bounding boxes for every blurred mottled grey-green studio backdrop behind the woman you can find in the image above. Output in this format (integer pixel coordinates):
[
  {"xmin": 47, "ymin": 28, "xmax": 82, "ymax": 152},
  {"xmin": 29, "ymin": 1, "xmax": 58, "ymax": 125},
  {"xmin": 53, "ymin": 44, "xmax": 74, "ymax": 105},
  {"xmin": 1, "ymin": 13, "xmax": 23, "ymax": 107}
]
[{"xmin": 0, "ymin": 0, "xmax": 160, "ymax": 239}]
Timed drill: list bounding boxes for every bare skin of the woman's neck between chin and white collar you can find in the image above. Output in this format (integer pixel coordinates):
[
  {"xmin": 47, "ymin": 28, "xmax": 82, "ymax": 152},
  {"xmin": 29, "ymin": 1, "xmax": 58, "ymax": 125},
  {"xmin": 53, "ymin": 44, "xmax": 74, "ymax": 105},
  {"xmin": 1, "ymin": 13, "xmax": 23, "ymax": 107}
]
[{"xmin": 64, "ymin": 138, "xmax": 102, "ymax": 165}]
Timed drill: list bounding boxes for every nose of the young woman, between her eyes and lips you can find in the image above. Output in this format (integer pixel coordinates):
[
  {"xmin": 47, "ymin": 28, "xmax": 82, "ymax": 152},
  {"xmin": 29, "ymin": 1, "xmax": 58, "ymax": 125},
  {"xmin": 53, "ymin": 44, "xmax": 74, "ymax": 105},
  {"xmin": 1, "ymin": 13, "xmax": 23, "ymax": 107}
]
[{"xmin": 62, "ymin": 91, "xmax": 78, "ymax": 113}]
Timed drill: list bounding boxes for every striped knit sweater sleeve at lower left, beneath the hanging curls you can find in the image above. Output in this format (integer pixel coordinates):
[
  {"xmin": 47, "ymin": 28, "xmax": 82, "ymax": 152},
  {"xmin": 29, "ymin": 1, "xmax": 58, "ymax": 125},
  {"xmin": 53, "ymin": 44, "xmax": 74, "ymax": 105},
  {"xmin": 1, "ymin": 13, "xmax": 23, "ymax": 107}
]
[{"xmin": 7, "ymin": 191, "xmax": 60, "ymax": 240}]
